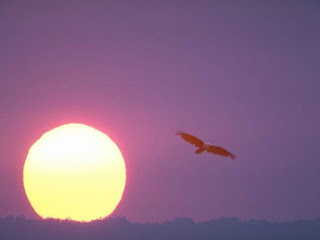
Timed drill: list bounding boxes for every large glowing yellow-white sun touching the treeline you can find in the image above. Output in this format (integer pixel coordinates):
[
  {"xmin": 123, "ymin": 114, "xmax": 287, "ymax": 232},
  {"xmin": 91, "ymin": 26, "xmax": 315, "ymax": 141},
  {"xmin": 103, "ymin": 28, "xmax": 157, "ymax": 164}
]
[{"xmin": 23, "ymin": 123, "xmax": 126, "ymax": 222}]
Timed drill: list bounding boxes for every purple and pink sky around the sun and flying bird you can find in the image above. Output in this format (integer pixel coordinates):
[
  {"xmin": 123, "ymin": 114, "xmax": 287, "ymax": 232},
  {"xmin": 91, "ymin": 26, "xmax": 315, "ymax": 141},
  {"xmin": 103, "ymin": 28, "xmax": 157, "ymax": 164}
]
[{"xmin": 0, "ymin": 0, "xmax": 320, "ymax": 222}]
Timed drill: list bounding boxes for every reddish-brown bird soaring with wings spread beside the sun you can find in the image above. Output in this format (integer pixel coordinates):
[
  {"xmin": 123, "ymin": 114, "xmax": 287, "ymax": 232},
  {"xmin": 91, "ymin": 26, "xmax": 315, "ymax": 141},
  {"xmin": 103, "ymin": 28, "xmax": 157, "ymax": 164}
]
[{"xmin": 176, "ymin": 131, "xmax": 236, "ymax": 160}]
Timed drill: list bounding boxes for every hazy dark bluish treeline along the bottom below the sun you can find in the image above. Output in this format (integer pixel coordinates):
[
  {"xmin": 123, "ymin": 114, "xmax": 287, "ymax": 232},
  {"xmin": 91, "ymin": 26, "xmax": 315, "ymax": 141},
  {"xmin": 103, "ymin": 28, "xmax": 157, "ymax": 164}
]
[{"xmin": 0, "ymin": 216, "xmax": 320, "ymax": 240}]
